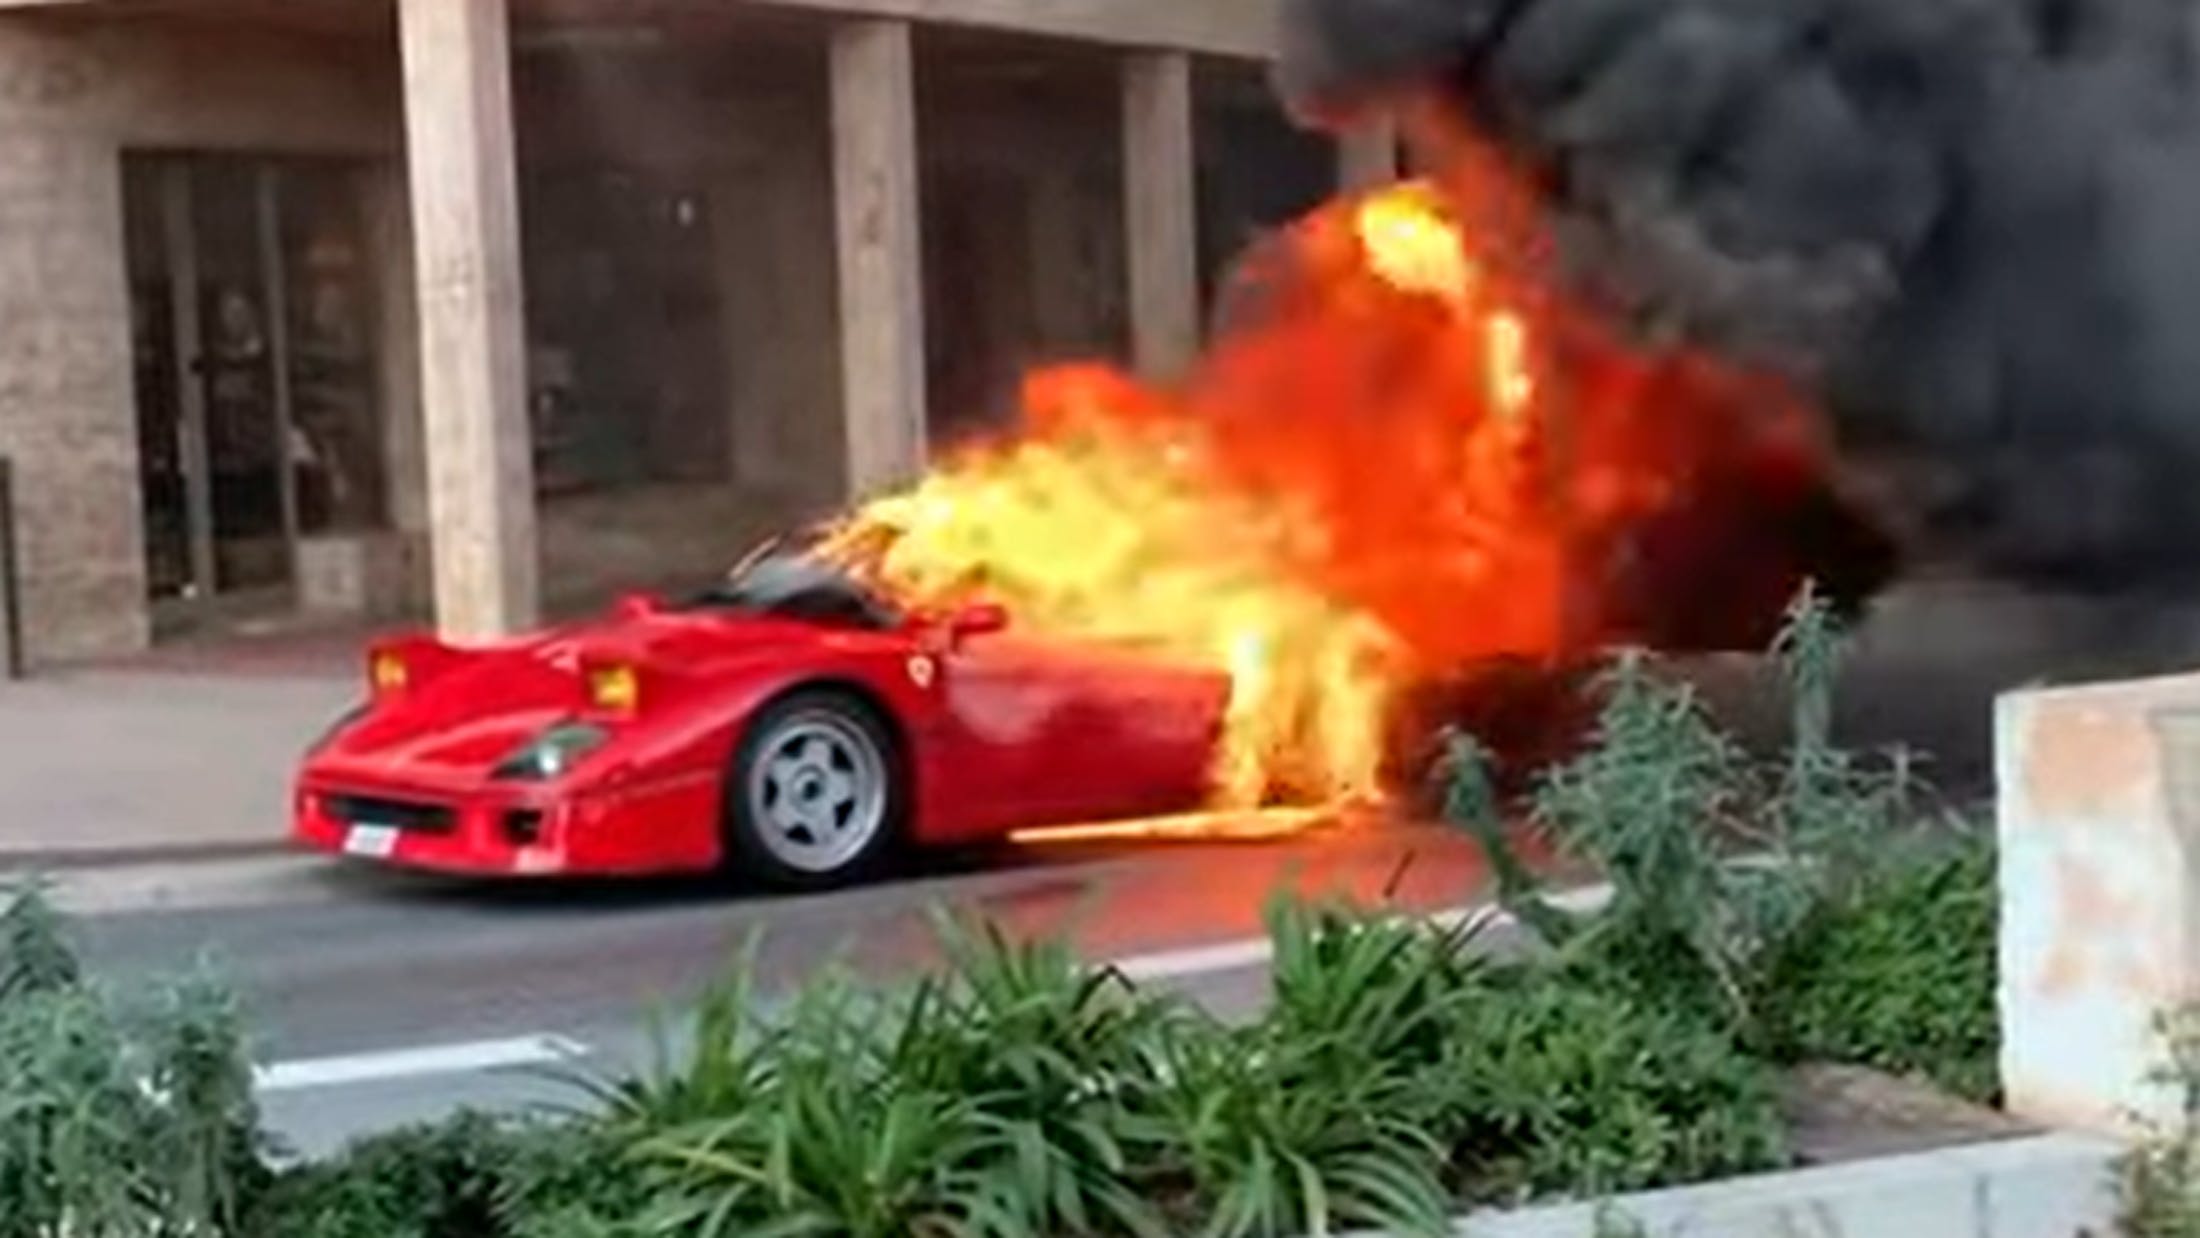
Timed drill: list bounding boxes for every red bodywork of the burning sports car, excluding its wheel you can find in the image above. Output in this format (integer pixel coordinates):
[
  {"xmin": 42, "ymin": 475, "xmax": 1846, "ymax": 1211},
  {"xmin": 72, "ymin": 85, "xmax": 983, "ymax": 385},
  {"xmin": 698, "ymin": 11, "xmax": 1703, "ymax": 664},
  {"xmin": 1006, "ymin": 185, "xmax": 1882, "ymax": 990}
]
[{"xmin": 293, "ymin": 580, "xmax": 1228, "ymax": 875}]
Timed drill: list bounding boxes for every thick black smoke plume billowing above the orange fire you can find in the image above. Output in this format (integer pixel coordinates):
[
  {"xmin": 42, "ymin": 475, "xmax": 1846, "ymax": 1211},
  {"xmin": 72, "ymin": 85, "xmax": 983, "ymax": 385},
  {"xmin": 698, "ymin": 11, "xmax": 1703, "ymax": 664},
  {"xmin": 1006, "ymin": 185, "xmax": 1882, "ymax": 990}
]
[{"xmin": 1276, "ymin": 0, "xmax": 2200, "ymax": 587}]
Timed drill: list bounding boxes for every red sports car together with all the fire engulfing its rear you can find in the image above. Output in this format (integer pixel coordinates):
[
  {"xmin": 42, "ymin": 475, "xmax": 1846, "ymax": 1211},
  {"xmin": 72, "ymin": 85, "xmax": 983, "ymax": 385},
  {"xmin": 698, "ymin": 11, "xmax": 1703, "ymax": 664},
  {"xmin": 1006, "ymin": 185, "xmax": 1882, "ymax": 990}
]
[{"xmin": 297, "ymin": 163, "xmax": 1894, "ymax": 884}]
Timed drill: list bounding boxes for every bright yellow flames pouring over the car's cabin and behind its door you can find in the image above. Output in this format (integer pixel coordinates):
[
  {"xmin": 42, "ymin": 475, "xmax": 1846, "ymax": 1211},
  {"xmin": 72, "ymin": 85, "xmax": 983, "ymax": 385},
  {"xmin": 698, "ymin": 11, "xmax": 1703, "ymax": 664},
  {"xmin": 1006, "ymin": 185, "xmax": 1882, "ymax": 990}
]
[{"xmin": 823, "ymin": 419, "xmax": 1388, "ymax": 807}]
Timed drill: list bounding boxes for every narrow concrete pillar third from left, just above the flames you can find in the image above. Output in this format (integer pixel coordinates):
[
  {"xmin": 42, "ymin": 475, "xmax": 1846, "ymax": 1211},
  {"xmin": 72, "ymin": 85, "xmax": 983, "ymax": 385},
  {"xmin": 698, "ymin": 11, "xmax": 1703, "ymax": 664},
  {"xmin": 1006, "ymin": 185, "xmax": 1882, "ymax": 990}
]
[{"xmin": 1122, "ymin": 51, "xmax": 1199, "ymax": 378}]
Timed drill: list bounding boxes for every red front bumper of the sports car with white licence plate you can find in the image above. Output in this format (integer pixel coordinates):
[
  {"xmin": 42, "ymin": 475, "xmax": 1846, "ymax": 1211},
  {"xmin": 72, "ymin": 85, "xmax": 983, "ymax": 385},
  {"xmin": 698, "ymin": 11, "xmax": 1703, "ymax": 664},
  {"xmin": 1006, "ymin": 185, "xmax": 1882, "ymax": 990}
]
[{"xmin": 290, "ymin": 765, "xmax": 719, "ymax": 877}]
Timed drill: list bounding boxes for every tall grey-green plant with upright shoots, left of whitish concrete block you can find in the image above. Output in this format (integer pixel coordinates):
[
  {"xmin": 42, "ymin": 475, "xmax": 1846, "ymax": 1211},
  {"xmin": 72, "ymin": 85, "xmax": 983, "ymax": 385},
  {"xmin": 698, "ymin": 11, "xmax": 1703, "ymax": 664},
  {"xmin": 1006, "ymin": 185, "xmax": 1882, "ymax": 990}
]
[{"xmin": 1443, "ymin": 589, "xmax": 1980, "ymax": 1047}]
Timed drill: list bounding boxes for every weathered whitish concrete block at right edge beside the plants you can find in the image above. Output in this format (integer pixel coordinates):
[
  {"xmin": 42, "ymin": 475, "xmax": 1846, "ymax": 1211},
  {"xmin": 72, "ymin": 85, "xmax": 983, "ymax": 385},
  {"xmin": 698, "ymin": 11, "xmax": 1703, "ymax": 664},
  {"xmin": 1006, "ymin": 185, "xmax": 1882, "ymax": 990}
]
[{"xmin": 1993, "ymin": 675, "xmax": 2200, "ymax": 1135}]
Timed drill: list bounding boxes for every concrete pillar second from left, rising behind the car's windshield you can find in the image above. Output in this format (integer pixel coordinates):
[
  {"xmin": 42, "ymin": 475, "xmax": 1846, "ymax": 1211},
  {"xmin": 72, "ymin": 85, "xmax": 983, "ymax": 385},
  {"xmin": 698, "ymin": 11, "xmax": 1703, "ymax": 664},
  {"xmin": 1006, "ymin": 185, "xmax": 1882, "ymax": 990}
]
[{"xmin": 832, "ymin": 20, "xmax": 926, "ymax": 497}]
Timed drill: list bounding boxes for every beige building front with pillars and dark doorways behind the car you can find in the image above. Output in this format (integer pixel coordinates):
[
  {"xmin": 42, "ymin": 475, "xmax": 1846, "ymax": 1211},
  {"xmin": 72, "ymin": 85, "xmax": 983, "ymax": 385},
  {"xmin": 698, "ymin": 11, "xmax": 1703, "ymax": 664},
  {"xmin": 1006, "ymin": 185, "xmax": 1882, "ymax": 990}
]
[{"xmin": 0, "ymin": 0, "xmax": 1395, "ymax": 666}]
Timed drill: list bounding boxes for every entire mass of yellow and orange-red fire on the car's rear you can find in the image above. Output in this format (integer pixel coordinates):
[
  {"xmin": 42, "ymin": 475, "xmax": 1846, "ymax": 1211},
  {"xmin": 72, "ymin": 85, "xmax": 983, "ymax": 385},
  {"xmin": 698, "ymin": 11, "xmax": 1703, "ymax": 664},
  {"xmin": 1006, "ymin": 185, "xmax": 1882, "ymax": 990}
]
[{"xmin": 825, "ymin": 128, "xmax": 1813, "ymax": 809}]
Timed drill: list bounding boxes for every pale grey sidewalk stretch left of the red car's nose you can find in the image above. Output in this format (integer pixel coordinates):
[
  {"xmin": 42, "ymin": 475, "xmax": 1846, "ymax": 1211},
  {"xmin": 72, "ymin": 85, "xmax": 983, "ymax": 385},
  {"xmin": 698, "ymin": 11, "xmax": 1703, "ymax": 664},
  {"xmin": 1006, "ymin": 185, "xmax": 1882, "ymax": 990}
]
[{"xmin": 0, "ymin": 664, "xmax": 359, "ymax": 871}]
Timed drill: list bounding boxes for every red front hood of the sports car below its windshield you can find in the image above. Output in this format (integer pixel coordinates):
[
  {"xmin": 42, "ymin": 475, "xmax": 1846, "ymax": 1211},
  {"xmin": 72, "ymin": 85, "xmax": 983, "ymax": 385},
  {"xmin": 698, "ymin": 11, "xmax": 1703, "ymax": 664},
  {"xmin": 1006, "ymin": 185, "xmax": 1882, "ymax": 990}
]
[{"xmin": 328, "ymin": 611, "xmax": 878, "ymax": 776}]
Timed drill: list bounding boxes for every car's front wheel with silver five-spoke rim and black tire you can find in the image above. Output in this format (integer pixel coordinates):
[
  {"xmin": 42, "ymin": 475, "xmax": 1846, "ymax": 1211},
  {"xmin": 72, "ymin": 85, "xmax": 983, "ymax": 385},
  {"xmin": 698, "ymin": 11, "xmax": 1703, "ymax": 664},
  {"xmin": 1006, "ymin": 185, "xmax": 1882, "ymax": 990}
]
[{"xmin": 724, "ymin": 688, "xmax": 909, "ymax": 888}]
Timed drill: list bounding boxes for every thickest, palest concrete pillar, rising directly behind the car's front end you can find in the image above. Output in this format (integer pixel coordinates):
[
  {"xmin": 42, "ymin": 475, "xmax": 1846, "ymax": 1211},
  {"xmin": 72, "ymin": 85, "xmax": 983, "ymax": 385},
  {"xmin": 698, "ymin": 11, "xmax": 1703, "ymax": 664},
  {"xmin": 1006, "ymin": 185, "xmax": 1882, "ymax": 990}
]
[{"xmin": 398, "ymin": 0, "xmax": 539, "ymax": 640}]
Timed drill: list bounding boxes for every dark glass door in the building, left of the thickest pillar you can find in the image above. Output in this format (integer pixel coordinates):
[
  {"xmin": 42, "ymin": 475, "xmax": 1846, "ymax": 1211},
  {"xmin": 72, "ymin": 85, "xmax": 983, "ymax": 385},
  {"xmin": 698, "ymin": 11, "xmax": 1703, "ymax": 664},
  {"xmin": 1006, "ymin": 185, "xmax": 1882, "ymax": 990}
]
[{"xmin": 123, "ymin": 154, "xmax": 383, "ymax": 620}]
